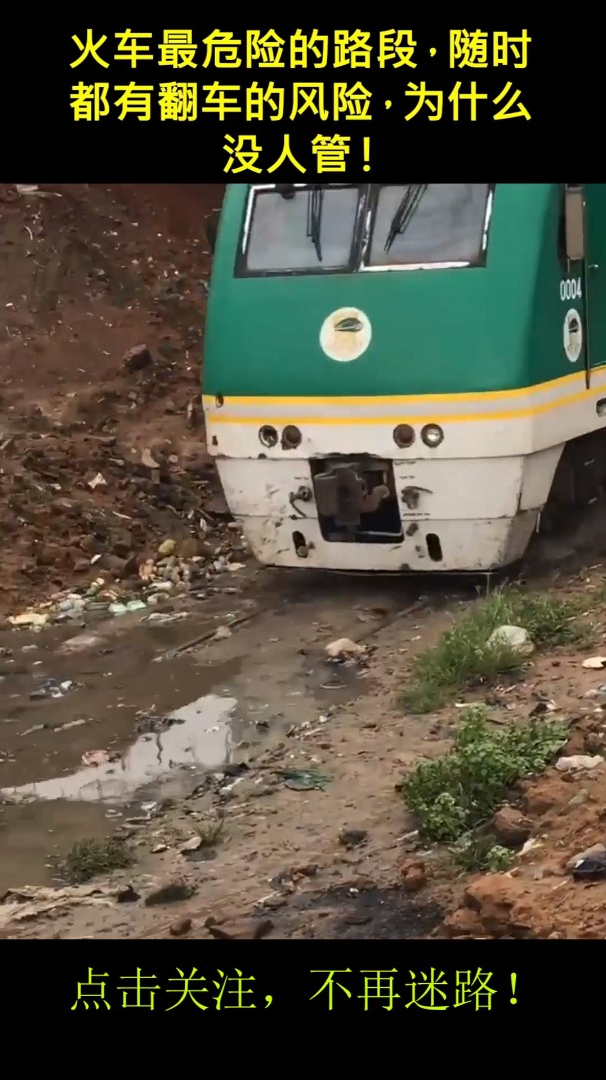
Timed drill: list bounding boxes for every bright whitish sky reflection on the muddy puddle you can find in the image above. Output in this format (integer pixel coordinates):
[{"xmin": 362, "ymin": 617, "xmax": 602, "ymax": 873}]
[{"xmin": 0, "ymin": 693, "xmax": 238, "ymax": 804}]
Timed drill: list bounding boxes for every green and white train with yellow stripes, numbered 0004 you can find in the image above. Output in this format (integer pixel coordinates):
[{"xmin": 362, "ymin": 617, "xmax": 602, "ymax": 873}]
[{"xmin": 202, "ymin": 184, "xmax": 606, "ymax": 573}]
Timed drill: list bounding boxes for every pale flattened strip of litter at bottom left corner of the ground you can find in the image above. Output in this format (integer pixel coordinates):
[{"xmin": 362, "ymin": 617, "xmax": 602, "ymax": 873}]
[{"xmin": 0, "ymin": 885, "xmax": 139, "ymax": 929}]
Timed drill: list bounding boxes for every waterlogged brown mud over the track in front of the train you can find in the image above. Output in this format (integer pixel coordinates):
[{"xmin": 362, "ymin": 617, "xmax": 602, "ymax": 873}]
[{"xmin": 0, "ymin": 571, "xmax": 462, "ymax": 928}]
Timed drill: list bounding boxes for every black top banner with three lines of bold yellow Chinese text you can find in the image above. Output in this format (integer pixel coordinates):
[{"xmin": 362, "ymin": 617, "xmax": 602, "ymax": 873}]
[{"xmin": 0, "ymin": 16, "xmax": 583, "ymax": 183}]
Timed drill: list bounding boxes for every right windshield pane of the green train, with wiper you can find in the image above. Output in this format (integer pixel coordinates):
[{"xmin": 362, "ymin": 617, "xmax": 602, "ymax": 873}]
[{"xmin": 368, "ymin": 184, "xmax": 489, "ymax": 267}]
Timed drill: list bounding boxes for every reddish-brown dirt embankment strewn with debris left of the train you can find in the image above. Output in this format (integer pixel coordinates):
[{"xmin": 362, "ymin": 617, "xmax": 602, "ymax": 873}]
[{"xmin": 0, "ymin": 185, "xmax": 223, "ymax": 616}]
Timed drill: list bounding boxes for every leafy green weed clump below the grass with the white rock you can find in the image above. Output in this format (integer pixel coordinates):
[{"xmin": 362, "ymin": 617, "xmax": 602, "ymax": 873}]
[{"xmin": 402, "ymin": 708, "xmax": 568, "ymax": 863}]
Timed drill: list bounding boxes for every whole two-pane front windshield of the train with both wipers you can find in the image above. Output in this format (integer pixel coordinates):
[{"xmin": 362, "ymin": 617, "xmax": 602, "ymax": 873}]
[{"xmin": 237, "ymin": 184, "xmax": 491, "ymax": 274}]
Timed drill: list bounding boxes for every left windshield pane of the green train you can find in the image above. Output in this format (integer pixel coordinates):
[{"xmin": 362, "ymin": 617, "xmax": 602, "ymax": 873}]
[{"xmin": 244, "ymin": 185, "xmax": 359, "ymax": 273}]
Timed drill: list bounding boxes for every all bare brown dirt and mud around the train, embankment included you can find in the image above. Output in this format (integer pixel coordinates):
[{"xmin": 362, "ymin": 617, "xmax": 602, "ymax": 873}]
[{"xmin": 0, "ymin": 185, "xmax": 606, "ymax": 937}]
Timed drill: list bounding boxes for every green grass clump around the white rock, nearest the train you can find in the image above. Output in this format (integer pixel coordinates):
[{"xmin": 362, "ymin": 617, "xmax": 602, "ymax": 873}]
[{"xmin": 401, "ymin": 588, "xmax": 596, "ymax": 713}]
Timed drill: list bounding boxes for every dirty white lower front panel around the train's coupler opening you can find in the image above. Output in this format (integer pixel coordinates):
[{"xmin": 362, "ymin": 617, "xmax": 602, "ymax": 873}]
[{"xmin": 216, "ymin": 446, "xmax": 563, "ymax": 572}]
